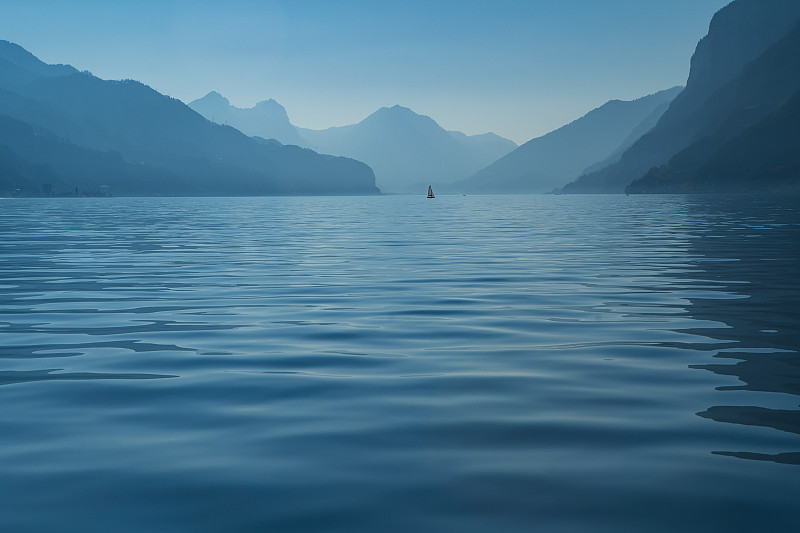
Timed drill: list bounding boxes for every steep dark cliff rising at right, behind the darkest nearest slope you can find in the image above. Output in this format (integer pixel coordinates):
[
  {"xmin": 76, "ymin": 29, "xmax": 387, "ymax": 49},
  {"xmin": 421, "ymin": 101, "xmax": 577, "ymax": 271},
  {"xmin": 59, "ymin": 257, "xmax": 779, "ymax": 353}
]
[{"xmin": 563, "ymin": 0, "xmax": 800, "ymax": 193}]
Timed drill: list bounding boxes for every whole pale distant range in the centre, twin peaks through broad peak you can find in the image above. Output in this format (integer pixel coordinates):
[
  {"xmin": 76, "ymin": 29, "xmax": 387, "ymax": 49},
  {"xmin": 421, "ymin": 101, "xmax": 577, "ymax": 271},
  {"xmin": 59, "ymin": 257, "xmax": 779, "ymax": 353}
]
[{"xmin": 189, "ymin": 96, "xmax": 517, "ymax": 193}]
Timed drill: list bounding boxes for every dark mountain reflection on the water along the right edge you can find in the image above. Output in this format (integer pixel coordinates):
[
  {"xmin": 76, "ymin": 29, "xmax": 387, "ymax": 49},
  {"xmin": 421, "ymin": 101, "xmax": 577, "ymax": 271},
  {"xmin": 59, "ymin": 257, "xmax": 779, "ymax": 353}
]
[{"xmin": 687, "ymin": 197, "xmax": 800, "ymax": 465}]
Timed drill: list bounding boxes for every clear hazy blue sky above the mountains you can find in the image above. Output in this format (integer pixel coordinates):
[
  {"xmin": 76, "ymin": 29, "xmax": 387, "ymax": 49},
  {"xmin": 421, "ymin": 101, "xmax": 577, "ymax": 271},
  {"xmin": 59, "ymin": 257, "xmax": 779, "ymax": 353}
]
[{"xmin": 0, "ymin": 0, "xmax": 729, "ymax": 142}]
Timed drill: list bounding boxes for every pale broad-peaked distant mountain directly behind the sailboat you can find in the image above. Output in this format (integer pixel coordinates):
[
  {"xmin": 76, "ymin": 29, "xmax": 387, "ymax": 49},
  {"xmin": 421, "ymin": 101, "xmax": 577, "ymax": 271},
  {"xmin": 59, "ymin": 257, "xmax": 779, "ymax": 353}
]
[{"xmin": 299, "ymin": 106, "xmax": 515, "ymax": 193}]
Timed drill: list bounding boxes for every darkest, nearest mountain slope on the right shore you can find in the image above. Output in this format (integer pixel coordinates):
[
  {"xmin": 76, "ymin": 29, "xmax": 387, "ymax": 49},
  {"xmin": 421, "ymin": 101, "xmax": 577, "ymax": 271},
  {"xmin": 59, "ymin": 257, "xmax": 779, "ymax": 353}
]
[{"xmin": 626, "ymin": 25, "xmax": 800, "ymax": 193}]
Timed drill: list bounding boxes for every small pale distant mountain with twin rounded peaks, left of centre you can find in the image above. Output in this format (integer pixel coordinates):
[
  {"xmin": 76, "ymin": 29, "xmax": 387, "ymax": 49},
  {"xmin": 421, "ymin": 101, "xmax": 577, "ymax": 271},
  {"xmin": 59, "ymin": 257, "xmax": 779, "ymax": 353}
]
[{"xmin": 189, "ymin": 91, "xmax": 308, "ymax": 148}]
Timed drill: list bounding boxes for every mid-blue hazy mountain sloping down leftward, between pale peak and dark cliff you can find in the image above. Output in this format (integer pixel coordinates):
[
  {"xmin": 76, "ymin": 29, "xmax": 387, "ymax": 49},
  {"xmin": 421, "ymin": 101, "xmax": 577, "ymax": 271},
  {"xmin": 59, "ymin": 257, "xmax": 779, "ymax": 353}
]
[{"xmin": 453, "ymin": 87, "xmax": 682, "ymax": 193}]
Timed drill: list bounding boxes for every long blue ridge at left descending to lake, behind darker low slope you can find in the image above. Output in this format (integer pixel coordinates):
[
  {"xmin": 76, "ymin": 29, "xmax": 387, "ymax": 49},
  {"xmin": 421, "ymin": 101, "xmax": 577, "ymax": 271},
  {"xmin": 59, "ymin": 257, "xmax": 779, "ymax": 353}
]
[{"xmin": 0, "ymin": 41, "xmax": 378, "ymax": 195}]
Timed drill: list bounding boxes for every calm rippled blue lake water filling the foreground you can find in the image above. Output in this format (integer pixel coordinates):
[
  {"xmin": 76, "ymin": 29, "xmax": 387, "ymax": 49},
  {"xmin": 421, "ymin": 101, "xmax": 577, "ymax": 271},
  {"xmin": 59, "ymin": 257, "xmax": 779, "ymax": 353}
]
[{"xmin": 0, "ymin": 196, "xmax": 800, "ymax": 532}]
